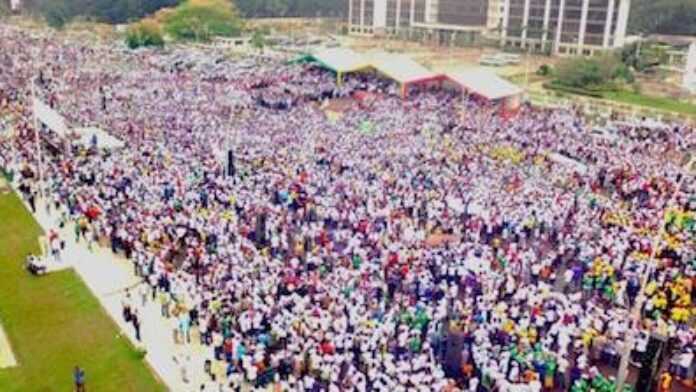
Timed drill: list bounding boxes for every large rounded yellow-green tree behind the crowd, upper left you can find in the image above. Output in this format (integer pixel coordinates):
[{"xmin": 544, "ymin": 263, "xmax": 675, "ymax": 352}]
[{"xmin": 165, "ymin": 0, "xmax": 243, "ymax": 41}]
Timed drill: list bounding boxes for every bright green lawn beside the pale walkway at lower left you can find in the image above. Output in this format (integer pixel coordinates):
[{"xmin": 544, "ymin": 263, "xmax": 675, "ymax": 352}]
[{"xmin": 0, "ymin": 193, "xmax": 165, "ymax": 392}]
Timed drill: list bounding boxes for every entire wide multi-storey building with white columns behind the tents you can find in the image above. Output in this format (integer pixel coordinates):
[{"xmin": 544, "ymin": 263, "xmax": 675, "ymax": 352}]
[{"xmin": 347, "ymin": 0, "xmax": 631, "ymax": 55}]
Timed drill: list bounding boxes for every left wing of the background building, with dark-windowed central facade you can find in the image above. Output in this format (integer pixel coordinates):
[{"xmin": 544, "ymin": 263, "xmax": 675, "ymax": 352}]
[{"xmin": 347, "ymin": 0, "xmax": 503, "ymax": 44}]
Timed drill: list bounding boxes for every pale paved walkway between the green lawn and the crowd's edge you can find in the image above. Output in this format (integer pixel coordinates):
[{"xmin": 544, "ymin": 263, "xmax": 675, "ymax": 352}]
[{"xmin": 16, "ymin": 189, "xmax": 212, "ymax": 392}]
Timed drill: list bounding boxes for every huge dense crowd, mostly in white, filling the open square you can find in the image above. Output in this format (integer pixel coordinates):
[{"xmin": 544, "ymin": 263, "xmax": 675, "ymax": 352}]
[{"xmin": 0, "ymin": 26, "xmax": 696, "ymax": 392}]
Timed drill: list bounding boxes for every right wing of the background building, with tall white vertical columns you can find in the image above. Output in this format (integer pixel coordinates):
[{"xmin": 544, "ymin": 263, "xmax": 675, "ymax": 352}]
[{"xmin": 500, "ymin": 0, "xmax": 631, "ymax": 55}]
